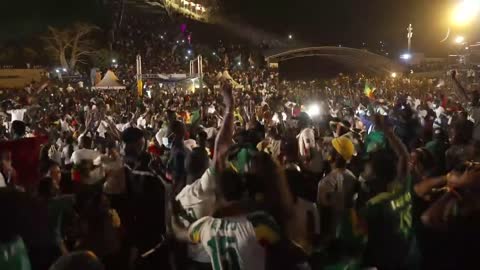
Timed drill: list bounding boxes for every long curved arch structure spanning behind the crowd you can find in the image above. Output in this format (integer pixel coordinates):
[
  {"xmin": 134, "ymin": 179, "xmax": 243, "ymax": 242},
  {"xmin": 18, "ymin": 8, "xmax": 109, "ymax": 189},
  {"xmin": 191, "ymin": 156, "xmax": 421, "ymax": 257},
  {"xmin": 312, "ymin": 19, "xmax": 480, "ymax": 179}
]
[{"xmin": 265, "ymin": 46, "xmax": 405, "ymax": 75}]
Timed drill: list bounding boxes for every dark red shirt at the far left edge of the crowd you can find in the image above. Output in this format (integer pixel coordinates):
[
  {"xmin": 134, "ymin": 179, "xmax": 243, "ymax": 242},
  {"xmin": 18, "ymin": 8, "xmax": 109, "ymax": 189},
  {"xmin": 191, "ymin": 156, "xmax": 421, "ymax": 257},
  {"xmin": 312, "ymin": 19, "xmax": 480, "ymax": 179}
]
[{"xmin": 0, "ymin": 136, "xmax": 48, "ymax": 187}]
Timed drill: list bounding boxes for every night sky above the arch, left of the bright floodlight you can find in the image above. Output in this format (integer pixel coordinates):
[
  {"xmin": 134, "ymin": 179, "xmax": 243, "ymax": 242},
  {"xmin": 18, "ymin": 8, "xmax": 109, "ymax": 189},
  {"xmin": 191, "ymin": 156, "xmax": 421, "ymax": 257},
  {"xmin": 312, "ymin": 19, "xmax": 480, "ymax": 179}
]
[{"xmin": 224, "ymin": 0, "xmax": 458, "ymax": 54}]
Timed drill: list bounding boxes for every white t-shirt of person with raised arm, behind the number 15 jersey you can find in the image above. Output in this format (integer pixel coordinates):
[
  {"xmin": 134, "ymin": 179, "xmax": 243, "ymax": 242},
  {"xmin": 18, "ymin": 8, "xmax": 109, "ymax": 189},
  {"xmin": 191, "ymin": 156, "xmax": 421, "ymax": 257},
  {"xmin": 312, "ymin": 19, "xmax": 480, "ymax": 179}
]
[{"xmin": 176, "ymin": 169, "xmax": 215, "ymax": 263}]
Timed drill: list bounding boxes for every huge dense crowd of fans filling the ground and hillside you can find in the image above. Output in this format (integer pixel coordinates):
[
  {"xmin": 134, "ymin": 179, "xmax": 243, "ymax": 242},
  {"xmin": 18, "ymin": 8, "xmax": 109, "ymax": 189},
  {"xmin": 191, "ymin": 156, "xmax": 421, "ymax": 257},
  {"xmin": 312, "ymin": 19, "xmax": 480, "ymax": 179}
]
[{"xmin": 0, "ymin": 2, "xmax": 480, "ymax": 270}]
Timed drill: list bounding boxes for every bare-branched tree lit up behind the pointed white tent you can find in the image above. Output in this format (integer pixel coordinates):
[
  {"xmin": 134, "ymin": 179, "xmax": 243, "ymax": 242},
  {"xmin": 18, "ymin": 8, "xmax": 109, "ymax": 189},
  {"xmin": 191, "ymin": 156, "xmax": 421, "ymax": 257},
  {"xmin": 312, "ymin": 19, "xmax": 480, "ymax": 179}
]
[{"xmin": 44, "ymin": 23, "xmax": 99, "ymax": 70}]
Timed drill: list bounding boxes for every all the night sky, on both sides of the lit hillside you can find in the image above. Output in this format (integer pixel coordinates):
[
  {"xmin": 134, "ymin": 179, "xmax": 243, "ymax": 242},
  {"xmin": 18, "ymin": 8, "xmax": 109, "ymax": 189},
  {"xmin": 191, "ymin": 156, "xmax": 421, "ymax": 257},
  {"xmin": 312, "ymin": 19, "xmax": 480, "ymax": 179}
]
[{"xmin": 0, "ymin": 0, "xmax": 472, "ymax": 55}]
